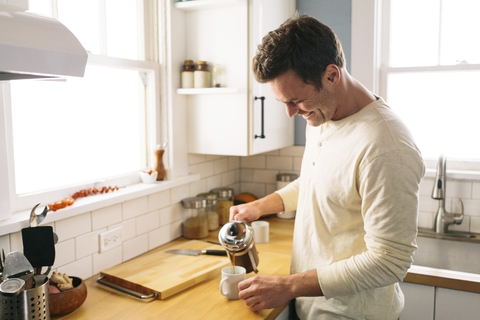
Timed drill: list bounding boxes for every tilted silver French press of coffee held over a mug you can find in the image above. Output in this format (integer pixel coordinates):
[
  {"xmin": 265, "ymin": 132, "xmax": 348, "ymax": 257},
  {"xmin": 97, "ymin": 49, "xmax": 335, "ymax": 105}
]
[{"xmin": 218, "ymin": 221, "xmax": 259, "ymax": 273}]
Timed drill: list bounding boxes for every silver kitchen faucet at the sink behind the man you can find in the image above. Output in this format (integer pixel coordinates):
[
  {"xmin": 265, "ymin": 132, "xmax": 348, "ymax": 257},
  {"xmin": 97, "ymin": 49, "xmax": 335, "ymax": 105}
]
[{"xmin": 432, "ymin": 154, "xmax": 463, "ymax": 233}]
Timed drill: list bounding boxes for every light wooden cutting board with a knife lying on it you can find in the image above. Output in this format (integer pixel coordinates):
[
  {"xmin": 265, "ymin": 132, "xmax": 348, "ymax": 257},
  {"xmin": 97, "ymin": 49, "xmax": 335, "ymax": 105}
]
[{"xmin": 100, "ymin": 240, "xmax": 230, "ymax": 299}]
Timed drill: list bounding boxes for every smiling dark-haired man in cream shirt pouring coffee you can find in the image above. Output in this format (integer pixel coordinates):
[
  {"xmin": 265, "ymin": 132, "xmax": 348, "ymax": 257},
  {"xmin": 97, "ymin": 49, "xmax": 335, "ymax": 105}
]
[{"xmin": 230, "ymin": 15, "xmax": 425, "ymax": 320}]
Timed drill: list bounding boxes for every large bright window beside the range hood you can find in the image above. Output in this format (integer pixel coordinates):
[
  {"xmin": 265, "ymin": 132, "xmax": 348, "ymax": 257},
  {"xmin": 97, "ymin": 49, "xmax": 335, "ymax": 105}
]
[{"xmin": 0, "ymin": 0, "xmax": 166, "ymax": 218}]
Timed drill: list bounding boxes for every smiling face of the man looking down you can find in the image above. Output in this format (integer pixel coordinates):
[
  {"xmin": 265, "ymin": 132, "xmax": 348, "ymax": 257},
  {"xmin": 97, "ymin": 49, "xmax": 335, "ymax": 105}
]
[{"xmin": 270, "ymin": 70, "xmax": 337, "ymax": 127}]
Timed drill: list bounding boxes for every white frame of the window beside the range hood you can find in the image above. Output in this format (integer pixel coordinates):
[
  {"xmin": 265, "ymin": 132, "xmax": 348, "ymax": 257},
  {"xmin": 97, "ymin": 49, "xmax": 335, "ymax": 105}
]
[{"xmin": 0, "ymin": 0, "xmax": 169, "ymax": 221}]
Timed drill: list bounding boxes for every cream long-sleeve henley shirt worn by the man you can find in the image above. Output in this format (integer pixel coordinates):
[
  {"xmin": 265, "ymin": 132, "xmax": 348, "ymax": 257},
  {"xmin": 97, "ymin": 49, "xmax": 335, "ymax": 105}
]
[{"xmin": 277, "ymin": 98, "xmax": 425, "ymax": 320}]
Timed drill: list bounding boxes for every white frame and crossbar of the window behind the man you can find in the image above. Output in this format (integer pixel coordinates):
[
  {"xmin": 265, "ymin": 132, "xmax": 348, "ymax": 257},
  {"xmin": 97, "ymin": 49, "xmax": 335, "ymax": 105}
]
[{"xmin": 351, "ymin": 0, "xmax": 480, "ymax": 180}]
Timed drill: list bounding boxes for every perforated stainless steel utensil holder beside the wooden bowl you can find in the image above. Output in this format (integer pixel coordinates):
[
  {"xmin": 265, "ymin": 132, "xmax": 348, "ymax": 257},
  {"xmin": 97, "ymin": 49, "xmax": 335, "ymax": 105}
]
[{"xmin": 0, "ymin": 277, "xmax": 50, "ymax": 320}]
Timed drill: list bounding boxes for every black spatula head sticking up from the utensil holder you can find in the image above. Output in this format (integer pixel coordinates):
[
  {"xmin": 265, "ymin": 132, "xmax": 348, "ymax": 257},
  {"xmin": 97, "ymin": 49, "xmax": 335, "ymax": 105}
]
[{"xmin": 22, "ymin": 226, "xmax": 55, "ymax": 272}]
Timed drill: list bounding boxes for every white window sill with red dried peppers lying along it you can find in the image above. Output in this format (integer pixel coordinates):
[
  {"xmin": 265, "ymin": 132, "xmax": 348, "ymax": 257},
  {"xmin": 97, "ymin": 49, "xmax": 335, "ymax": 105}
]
[{"xmin": 0, "ymin": 174, "xmax": 200, "ymax": 235}]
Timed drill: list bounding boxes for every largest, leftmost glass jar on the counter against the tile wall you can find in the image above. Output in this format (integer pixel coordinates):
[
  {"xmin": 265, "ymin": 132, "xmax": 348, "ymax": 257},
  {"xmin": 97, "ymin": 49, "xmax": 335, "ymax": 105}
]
[{"xmin": 182, "ymin": 197, "xmax": 208, "ymax": 239}]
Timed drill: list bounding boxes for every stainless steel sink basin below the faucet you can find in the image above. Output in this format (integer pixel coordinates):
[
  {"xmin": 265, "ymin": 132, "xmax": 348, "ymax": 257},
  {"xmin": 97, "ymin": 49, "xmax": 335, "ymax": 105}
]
[{"xmin": 413, "ymin": 229, "xmax": 480, "ymax": 274}]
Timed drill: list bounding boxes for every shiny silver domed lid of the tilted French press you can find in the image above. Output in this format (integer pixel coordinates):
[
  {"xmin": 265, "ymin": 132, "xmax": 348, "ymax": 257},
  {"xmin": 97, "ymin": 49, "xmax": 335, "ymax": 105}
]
[{"xmin": 218, "ymin": 221, "xmax": 253, "ymax": 252}]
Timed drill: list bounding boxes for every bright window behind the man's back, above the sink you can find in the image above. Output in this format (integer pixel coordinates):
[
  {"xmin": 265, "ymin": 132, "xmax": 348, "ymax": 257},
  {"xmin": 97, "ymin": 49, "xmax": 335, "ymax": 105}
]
[{"xmin": 380, "ymin": 0, "xmax": 480, "ymax": 160}]
